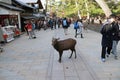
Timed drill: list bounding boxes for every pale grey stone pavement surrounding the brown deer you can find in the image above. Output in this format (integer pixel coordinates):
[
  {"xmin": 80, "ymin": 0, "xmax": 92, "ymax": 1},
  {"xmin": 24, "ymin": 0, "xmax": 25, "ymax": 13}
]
[{"xmin": 0, "ymin": 24, "xmax": 120, "ymax": 80}]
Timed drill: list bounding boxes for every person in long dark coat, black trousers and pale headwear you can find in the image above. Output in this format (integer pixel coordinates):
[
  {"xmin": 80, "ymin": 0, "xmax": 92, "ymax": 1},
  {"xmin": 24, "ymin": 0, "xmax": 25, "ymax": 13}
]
[{"xmin": 100, "ymin": 19, "xmax": 112, "ymax": 62}]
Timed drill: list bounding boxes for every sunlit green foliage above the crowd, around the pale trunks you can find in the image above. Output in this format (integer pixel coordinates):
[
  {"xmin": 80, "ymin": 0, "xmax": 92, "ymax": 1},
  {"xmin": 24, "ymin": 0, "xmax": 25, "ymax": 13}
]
[{"xmin": 48, "ymin": 0, "xmax": 120, "ymax": 17}]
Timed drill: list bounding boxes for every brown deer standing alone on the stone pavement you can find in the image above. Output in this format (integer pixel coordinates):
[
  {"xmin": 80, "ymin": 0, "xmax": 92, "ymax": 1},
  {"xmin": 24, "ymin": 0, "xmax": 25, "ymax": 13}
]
[{"xmin": 52, "ymin": 38, "xmax": 77, "ymax": 62}]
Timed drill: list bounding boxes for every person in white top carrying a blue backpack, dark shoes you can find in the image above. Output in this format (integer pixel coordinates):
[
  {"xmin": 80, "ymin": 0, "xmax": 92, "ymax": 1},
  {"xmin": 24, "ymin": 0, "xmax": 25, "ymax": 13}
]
[{"xmin": 74, "ymin": 20, "xmax": 83, "ymax": 38}]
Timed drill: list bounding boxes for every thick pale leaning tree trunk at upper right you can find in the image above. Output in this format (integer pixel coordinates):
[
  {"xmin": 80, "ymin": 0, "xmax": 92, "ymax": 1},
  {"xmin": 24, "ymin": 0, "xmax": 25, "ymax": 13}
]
[{"xmin": 95, "ymin": 0, "xmax": 112, "ymax": 17}]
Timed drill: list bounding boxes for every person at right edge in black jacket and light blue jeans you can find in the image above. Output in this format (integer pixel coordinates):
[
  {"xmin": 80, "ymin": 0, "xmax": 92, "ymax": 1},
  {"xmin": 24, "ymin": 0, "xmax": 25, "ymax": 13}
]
[{"xmin": 111, "ymin": 15, "xmax": 120, "ymax": 60}]
